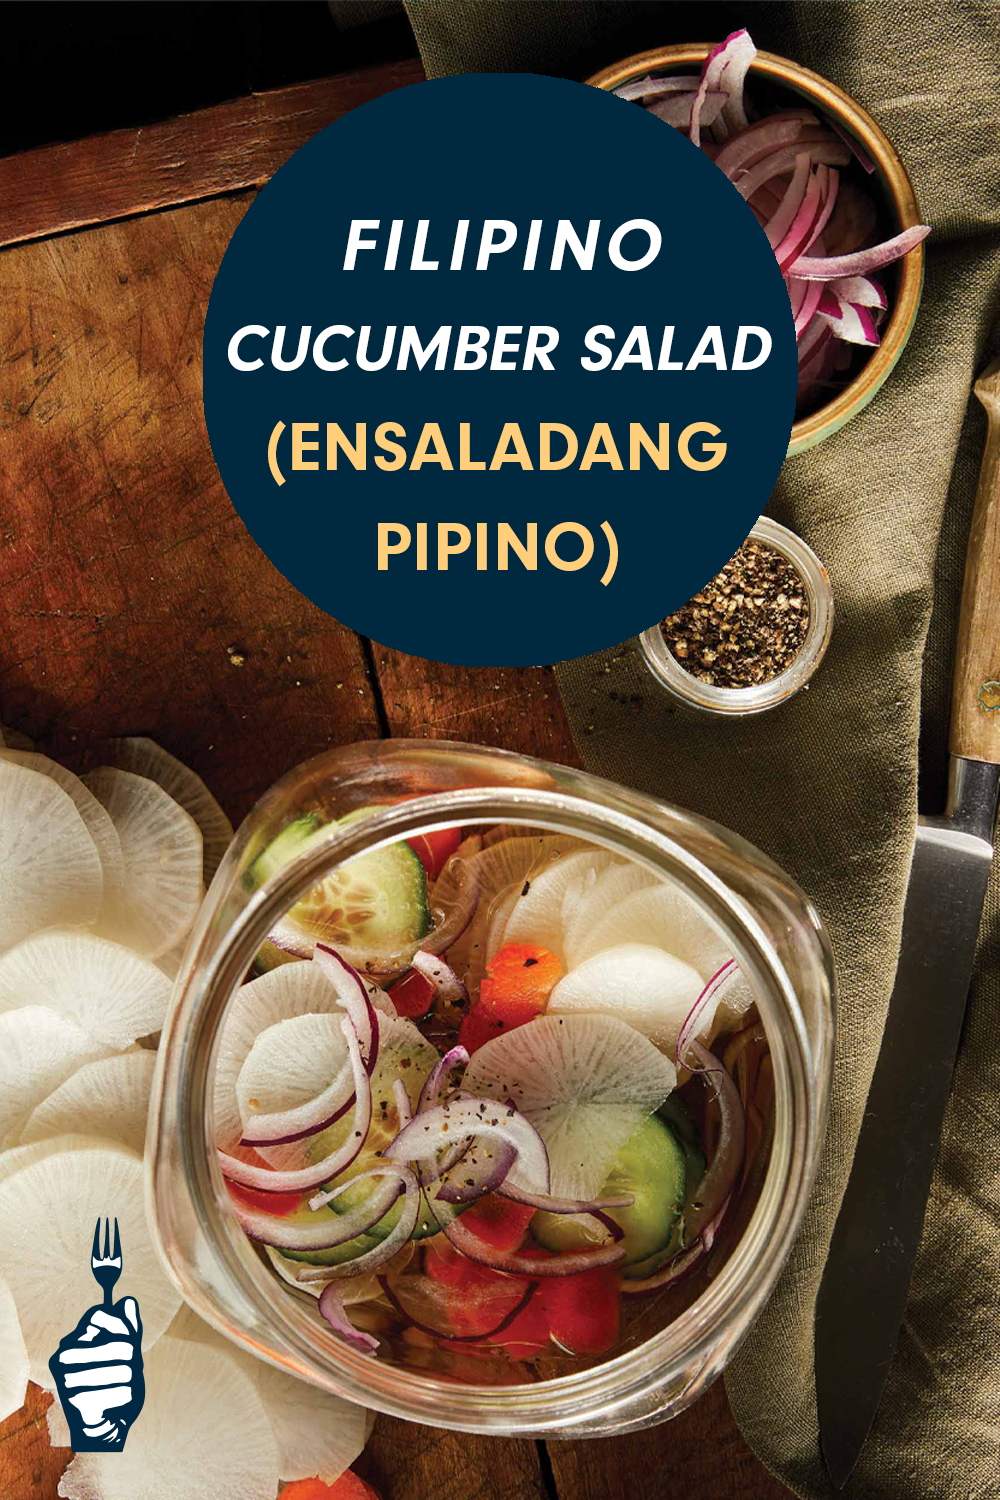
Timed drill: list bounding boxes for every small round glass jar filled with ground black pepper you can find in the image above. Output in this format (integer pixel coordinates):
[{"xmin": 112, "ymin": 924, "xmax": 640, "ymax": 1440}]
[{"xmin": 639, "ymin": 516, "xmax": 834, "ymax": 714}]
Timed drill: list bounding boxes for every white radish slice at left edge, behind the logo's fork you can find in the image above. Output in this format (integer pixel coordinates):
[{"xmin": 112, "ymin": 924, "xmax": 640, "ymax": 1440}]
[{"xmin": 0, "ymin": 1142, "xmax": 180, "ymax": 1380}]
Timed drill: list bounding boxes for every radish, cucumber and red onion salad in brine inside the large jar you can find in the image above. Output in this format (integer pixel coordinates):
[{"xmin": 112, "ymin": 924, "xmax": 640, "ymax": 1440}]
[{"xmin": 214, "ymin": 809, "xmax": 772, "ymax": 1385}]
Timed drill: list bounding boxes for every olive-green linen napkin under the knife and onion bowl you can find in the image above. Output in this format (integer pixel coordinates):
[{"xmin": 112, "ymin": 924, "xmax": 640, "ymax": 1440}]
[{"xmin": 408, "ymin": 0, "xmax": 1000, "ymax": 1500}]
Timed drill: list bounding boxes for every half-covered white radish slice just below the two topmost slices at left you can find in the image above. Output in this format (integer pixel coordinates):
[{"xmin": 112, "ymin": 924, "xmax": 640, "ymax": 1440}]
[{"xmin": 0, "ymin": 927, "xmax": 171, "ymax": 1050}]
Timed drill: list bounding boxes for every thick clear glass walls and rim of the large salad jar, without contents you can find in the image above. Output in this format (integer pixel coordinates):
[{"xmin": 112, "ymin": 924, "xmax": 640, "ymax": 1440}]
[{"xmin": 147, "ymin": 741, "xmax": 832, "ymax": 1437}]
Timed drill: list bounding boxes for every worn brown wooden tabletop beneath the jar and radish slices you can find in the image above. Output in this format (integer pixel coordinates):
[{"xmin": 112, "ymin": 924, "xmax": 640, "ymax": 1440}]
[{"xmin": 0, "ymin": 62, "xmax": 790, "ymax": 1500}]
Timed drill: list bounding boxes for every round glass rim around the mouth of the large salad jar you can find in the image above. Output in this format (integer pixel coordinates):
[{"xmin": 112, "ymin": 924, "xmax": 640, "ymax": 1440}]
[{"xmin": 151, "ymin": 741, "xmax": 825, "ymax": 1433}]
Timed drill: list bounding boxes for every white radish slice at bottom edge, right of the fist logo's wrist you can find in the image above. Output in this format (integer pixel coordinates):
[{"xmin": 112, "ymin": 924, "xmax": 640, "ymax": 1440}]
[{"xmin": 58, "ymin": 1338, "xmax": 279, "ymax": 1500}]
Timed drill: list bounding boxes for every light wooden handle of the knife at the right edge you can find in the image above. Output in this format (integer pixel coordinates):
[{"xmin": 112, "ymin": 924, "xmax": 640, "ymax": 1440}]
[{"xmin": 951, "ymin": 360, "xmax": 1000, "ymax": 765}]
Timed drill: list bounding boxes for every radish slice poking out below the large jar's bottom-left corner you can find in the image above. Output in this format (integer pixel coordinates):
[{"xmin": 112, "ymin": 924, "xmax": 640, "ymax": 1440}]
[{"xmin": 169, "ymin": 1308, "xmax": 370, "ymax": 1485}]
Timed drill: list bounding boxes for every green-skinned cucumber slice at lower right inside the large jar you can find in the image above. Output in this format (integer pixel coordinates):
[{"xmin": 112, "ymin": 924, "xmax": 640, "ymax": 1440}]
[{"xmin": 531, "ymin": 1115, "xmax": 687, "ymax": 1266}]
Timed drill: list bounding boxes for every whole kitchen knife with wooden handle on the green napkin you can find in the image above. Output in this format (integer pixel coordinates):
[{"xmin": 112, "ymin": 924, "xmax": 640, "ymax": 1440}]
[{"xmin": 816, "ymin": 360, "xmax": 1000, "ymax": 1490}]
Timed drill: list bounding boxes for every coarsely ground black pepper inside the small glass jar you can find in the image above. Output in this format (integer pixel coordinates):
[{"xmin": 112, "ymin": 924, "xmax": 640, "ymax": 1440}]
[{"xmin": 660, "ymin": 539, "xmax": 810, "ymax": 687}]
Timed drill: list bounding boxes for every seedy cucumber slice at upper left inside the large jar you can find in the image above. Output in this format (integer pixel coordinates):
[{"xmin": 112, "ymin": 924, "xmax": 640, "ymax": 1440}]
[{"xmin": 249, "ymin": 807, "xmax": 430, "ymax": 969}]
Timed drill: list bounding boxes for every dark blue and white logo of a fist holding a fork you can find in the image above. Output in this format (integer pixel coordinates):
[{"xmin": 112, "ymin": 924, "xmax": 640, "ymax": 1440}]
[{"xmin": 48, "ymin": 1220, "xmax": 145, "ymax": 1454}]
